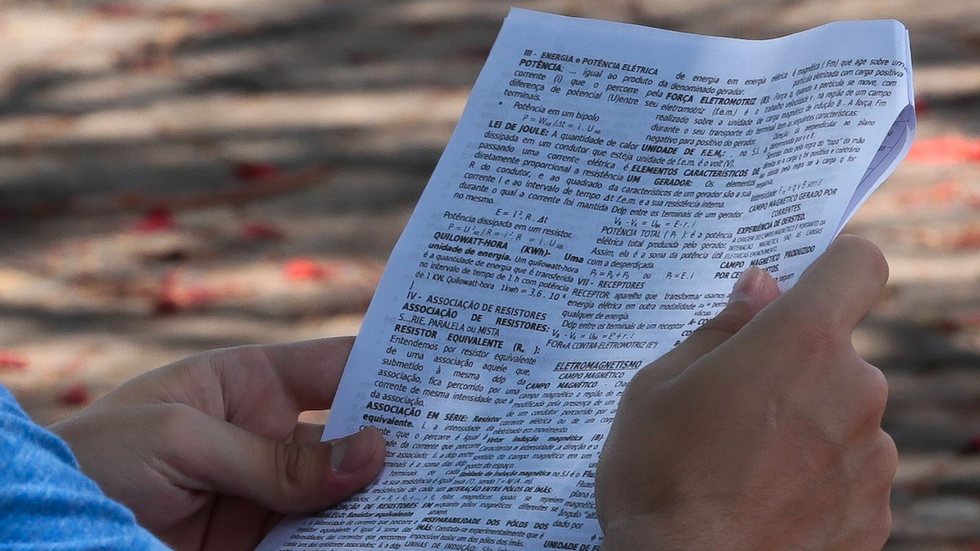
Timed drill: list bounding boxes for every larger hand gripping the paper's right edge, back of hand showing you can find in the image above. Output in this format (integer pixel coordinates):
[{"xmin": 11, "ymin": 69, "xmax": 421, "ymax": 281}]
[{"xmin": 596, "ymin": 236, "xmax": 897, "ymax": 551}]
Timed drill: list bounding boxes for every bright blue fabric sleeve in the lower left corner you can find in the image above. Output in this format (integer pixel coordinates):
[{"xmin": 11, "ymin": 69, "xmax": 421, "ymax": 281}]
[{"xmin": 0, "ymin": 386, "xmax": 167, "ymax": 551}]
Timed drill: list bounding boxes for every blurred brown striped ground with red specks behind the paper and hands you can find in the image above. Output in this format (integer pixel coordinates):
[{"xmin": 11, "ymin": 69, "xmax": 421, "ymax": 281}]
[{"xmin": 0, "ymin": 0, "xmax": 980, "ymax": 550}]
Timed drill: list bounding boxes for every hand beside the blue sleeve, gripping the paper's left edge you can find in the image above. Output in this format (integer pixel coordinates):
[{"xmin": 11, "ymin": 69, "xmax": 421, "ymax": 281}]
[{"xmin": 50, "ymin": 338, "xmax": 385, "ymax": 549}]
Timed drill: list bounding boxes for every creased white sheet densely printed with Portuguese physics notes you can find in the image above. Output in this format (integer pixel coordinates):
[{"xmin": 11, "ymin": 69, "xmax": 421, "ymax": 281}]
[{"xmin": 263, "ymin": 10, "xmax": 915, "ymax": 551}]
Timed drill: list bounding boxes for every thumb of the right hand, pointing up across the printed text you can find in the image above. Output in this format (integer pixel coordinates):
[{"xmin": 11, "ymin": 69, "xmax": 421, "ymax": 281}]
[{"xmin": 651, "ymin": 266, "xmax": 779, "ymax": 380}]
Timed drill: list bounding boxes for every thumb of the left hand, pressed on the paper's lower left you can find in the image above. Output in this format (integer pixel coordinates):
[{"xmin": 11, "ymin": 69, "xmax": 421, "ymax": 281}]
[{"xmin": 172, "ymin": 410, "xmax": 385, "ymax": 513}]
